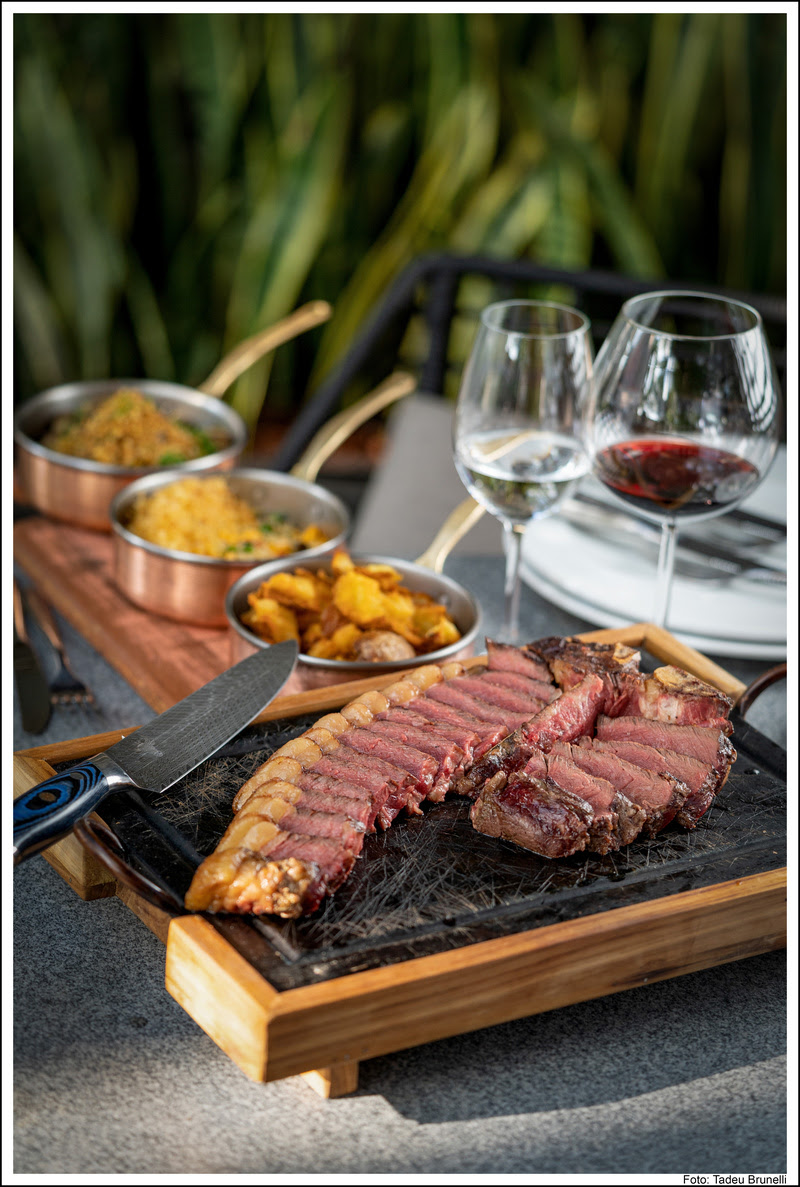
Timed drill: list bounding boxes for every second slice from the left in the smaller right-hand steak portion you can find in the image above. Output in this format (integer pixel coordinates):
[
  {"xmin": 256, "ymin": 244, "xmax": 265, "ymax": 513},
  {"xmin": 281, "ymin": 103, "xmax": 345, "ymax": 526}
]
[{"xmin": 523, "ymin": 743, "xmax": 646, "ymax": 853}]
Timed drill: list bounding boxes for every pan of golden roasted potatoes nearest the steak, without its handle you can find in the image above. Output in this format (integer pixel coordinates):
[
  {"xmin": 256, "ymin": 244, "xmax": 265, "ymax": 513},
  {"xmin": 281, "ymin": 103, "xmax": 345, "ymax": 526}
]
[{"xmin": 226, "ymin": 546, "xmax": 481, "ymax": 693}]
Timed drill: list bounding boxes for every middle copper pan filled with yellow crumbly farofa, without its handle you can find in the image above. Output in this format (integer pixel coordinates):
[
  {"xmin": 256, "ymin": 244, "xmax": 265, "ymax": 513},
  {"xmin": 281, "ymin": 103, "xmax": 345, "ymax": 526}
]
[{"xmin": 110, "ymin": 468, "xmax": 350, "ymax": 627}]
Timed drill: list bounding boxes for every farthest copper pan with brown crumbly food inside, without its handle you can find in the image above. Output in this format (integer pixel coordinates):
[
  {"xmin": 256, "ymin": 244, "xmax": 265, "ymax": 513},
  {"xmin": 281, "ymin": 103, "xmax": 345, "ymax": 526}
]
[{"xmin": 14, "ymin": 380, "xmax": 247, "ymax": 532}]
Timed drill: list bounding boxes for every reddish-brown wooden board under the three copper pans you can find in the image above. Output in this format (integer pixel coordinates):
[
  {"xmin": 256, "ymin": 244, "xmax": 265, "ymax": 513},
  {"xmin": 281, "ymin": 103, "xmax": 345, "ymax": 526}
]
[{"xmin": 14, "ymin": 518, "xmax": 230, "ymax": 713}]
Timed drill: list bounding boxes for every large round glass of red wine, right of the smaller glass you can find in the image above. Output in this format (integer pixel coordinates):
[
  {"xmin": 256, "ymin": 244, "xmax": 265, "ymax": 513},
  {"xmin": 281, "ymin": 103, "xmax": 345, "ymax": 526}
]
[{"xmin": 586, "ymin": 292, "xmax": 779, "ymax": 627}]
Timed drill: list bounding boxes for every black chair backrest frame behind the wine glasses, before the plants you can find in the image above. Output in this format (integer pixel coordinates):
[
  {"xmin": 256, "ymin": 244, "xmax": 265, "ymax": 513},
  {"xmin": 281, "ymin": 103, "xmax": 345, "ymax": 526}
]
[{"xmin": 271, "ymin": 254, "xmax": 786, "ymax": 470}]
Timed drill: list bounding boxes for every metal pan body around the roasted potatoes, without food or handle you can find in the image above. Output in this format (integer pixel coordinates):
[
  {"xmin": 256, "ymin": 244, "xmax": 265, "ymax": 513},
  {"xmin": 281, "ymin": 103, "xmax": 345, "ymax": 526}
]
[{"xmin": 226, "ymin": 556, "xmax": 481, "ymax": 694}]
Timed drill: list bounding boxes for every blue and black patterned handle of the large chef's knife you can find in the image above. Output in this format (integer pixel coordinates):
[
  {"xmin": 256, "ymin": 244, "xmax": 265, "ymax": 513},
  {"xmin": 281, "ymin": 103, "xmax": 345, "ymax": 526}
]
[{"xmin": 14, "ymin": 754, "xmax": 131, "ymax": 864}]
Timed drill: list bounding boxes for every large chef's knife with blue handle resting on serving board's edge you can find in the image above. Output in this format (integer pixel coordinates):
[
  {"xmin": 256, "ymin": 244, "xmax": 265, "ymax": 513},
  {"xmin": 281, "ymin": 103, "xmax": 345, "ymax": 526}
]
[{"xmin": 14, "ymin": 640, "xmax": 297, "ymax": 864}]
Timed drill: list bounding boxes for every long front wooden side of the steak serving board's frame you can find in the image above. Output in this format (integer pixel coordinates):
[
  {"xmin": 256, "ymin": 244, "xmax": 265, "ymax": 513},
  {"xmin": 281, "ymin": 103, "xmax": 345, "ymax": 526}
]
[{"xmin": 258, "ymin": 870, "xmax": 786, "ymax": 1080}]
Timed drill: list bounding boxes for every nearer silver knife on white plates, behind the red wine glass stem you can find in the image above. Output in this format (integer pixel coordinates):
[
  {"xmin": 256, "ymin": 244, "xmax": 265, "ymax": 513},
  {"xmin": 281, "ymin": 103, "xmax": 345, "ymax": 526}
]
[{"xmin": 567, "ymin": 493, "xmax": 787, "ymax": 585}]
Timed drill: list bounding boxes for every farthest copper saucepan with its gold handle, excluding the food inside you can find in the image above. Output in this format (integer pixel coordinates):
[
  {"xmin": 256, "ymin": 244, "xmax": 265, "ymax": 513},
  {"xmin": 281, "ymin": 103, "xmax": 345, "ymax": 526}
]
[{"xmin": 14, "ymin": 301, "xmax": 332, "ymax": 532}]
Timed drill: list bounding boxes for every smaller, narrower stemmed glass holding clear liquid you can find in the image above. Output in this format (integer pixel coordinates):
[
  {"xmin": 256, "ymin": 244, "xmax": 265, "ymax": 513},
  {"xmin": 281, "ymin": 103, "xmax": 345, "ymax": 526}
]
[{"xmin": 453, "ymin": 300, "xmax": 591, "ymax": 642}]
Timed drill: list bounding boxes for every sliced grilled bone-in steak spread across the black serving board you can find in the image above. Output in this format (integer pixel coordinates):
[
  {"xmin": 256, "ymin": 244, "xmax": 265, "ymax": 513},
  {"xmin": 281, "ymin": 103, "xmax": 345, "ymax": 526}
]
[{"xmin": 186, "ymin": 639, "xmax": 736, "ymax": 918}]
